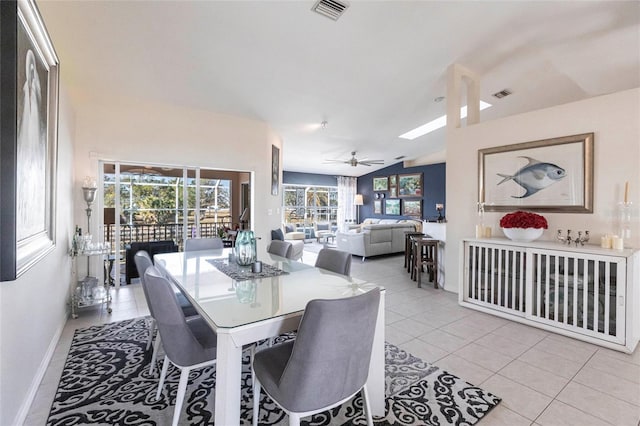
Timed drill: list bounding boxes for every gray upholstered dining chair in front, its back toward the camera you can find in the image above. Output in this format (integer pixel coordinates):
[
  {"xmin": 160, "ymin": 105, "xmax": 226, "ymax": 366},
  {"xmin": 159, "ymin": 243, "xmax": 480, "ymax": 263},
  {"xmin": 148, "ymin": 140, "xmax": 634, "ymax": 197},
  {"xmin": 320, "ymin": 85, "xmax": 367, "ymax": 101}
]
[{"xmin": 252, "ymin": 288, "xmax": 380, "ymax": 426}]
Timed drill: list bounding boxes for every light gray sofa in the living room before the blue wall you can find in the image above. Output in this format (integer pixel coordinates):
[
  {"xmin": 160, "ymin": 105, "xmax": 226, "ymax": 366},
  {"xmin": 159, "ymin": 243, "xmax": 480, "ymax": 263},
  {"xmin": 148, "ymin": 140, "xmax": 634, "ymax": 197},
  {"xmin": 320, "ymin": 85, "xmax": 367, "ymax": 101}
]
[{"xmin": 336, "ymin": 219, "xmax": 422, "ymax": 260}]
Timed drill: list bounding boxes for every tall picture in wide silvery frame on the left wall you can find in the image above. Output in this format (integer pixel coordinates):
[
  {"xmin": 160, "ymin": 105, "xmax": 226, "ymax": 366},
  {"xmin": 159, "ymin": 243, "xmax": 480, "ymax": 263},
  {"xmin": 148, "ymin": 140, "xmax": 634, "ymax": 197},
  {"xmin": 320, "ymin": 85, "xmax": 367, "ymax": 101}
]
[{"xmin": 0, "ymin": 1, "xmax": 59, "ymax": 281}]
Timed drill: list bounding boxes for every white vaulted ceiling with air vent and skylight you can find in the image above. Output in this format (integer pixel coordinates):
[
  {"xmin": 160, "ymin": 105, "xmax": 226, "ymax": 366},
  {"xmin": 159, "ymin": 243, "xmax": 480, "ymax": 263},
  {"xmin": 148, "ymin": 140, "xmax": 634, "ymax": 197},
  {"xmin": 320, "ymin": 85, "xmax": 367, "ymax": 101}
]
[{"xmin": 38, "ymin": 0, "xmax": 640, "ymax": 176}]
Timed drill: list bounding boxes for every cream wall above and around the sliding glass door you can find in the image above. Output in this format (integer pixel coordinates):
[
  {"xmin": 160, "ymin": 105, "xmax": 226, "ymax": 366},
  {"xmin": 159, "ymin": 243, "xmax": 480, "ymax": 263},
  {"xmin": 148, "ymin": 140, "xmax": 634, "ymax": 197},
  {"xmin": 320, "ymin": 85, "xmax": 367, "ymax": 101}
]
[{"xmin": 69, "ymin": 93, "xmax": 282, "ymax": 256}]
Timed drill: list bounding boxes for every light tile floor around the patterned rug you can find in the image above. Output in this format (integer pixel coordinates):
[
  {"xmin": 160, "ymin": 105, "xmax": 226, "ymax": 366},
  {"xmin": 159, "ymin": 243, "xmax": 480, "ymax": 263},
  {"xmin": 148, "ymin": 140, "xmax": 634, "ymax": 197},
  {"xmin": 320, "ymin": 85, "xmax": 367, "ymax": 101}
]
[{"xmin": 25, "ymin": 251, "xmax": 640, "ymax": 426}]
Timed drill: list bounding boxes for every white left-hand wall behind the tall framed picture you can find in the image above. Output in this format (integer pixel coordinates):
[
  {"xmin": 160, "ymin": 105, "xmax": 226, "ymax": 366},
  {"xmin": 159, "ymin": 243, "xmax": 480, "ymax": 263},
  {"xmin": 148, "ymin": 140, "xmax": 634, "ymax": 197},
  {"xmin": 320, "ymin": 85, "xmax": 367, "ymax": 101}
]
[{"xmin": 0, "ymin": 87, "xmax": 74, "ymax": 425}]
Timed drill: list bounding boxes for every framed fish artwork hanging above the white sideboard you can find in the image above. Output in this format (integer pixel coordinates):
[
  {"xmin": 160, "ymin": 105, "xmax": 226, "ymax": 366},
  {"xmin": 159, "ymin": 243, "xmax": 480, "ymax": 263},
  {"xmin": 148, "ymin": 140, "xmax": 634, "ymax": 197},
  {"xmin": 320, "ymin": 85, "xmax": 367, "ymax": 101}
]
[{"xmin": 478, "ymin": 133, "xmax": 593, "ymax": 213}]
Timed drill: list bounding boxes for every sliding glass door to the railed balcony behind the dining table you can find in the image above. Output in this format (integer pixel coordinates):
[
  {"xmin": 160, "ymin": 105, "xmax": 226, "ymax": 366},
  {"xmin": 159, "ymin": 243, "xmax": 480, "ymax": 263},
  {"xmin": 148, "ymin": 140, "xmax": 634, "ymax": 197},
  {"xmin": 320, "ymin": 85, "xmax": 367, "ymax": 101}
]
[{"xmin": 101, "ymin": 162, "xmax": 251, "ymax": 286}]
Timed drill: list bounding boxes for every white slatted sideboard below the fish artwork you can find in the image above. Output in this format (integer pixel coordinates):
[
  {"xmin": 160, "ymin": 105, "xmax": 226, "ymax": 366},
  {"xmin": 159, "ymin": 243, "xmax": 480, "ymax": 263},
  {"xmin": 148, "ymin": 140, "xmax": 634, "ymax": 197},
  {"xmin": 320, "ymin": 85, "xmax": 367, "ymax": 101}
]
[{"xmin": 458, "ymin": 238, "xmax": 640, "ymax": 353}]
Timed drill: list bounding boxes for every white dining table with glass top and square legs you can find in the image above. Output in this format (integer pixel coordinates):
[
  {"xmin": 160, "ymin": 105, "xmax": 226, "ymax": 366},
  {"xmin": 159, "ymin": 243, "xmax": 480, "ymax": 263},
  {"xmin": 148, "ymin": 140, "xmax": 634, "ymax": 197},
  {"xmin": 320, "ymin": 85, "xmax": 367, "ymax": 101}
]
[{"xmin": 154, "ymin": 248, "xmax": 385, "ymax": 426}]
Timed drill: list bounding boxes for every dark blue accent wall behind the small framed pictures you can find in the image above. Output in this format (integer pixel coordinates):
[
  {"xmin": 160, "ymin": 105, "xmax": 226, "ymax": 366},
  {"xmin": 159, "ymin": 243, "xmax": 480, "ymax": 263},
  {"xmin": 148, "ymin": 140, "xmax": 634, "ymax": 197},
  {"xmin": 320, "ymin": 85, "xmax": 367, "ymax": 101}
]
[{"xmin": 358, "ymin": 163, "xmax": 447, "ymax": 221}]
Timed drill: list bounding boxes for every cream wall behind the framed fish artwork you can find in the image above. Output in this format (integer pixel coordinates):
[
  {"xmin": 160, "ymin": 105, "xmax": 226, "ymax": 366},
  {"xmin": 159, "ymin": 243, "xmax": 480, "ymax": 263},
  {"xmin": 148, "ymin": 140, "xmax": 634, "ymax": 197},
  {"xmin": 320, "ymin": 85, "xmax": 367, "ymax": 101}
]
[{"xmin": 446, "ymin": 89, "xmax": 640, "ymax": 292}]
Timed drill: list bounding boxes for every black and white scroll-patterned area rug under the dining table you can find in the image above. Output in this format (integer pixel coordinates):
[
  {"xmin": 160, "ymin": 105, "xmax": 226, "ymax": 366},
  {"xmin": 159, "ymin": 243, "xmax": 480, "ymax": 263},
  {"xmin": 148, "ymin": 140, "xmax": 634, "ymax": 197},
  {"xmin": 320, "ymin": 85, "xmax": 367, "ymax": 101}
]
[{"xmin": 47, "ymin": 318, "xmax": 500, "ymax": 425}]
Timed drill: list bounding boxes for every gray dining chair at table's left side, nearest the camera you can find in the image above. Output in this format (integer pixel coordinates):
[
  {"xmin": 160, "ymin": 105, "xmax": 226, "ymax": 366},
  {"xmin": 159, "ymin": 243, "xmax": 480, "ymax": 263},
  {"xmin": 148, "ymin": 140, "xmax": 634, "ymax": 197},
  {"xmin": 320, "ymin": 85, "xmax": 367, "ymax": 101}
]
[{"xmin": 145, "ymin": 266, "xmax": 217, "ymax": 426}]
